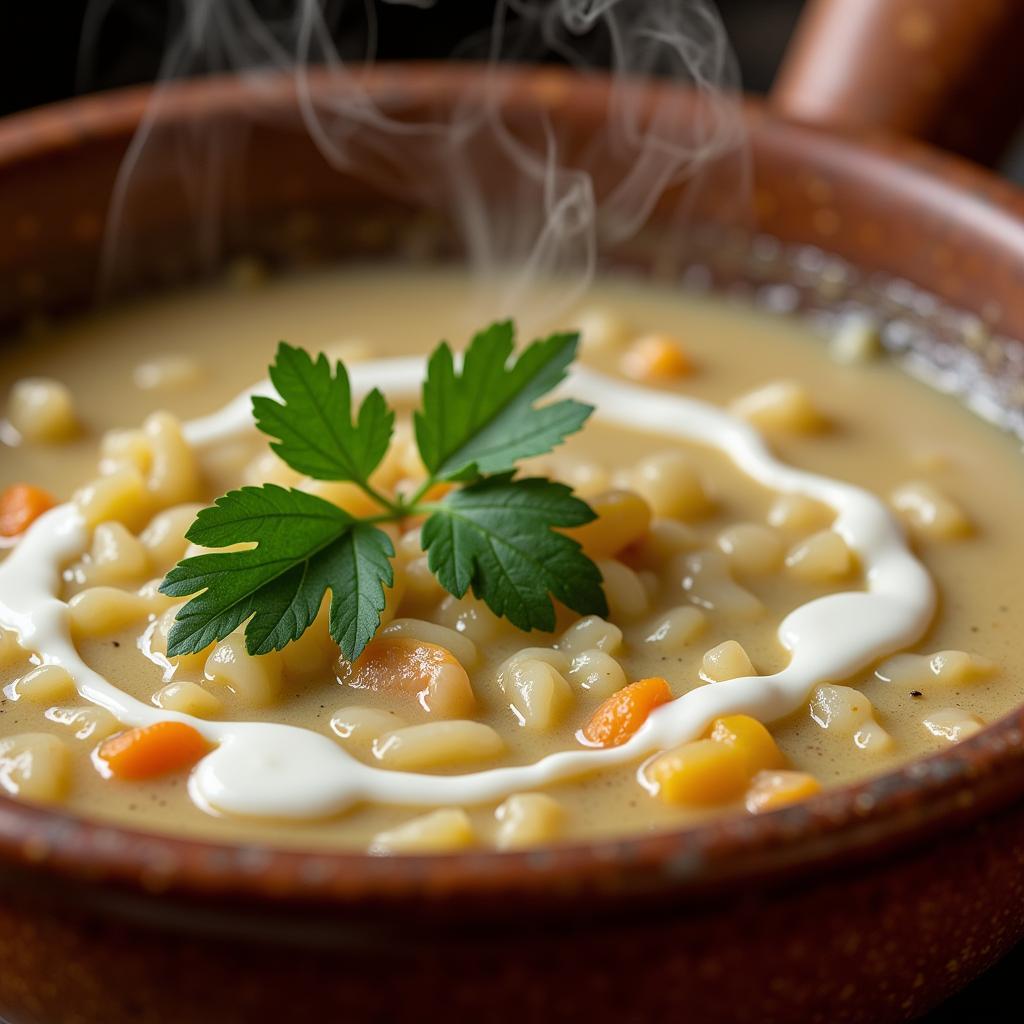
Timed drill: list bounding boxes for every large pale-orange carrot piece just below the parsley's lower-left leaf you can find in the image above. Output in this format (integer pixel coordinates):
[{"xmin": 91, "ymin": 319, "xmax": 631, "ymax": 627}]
[{"xmin": 339, "ymin": 636, "xmax": 476, "ymax": 718}]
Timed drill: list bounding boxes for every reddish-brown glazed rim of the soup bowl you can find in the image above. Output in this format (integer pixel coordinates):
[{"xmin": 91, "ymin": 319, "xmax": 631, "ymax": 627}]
[{"xmin": 0, "ymin": 66, "xmax": 1024, "ymax": 913}]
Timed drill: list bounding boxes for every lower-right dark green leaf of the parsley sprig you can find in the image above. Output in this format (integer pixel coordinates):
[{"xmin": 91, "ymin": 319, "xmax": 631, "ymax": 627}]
[{"xmin": 421, "ymin": 473, "xmax": 608, "ymax": 632}]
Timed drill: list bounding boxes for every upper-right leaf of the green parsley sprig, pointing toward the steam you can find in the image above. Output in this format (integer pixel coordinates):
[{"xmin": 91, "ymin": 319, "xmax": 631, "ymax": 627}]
[{"xmin": 416, "ymin": 321, "xmax": 593, "ymax": 480}]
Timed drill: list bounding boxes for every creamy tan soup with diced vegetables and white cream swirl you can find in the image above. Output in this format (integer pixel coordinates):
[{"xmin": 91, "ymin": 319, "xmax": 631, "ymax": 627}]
[{"xmin": 0, "ymin": 269, "xmax": 1024, "ymax": 853}]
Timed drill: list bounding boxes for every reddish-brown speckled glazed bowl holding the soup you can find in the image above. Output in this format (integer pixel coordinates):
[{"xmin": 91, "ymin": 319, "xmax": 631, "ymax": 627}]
[{"xmin": 0, "ymin": 68, "xmax": 1024, "ymax": 1024}]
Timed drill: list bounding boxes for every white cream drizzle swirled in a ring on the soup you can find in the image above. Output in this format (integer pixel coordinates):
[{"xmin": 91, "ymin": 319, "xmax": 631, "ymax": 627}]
[{"xmin": 0, "ymin": 358, "xmax": 936, "ymax": 819}]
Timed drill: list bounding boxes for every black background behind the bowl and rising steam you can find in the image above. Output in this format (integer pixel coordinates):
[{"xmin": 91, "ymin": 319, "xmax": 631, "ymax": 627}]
[{"xmin": 0, "ymin": 0, "xmax": 1024, "ymax": 1024}]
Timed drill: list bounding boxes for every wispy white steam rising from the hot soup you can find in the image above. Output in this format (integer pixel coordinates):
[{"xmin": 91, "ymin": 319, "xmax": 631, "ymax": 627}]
[{"xmin": 83, "ymin": 0, "xmax": 745, "ymax": 323}]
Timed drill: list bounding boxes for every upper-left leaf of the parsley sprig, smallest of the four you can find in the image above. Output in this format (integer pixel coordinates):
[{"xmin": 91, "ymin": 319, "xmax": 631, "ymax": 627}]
[{"xmin": 253, "ymin": 342, "xmax": 394, "ymax": 483}]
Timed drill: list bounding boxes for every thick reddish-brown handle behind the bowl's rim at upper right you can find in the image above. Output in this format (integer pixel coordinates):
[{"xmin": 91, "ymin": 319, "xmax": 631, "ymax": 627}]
[{"xmin": 772, "ymin": 0, "xmax": 1024, "ymax": 163}]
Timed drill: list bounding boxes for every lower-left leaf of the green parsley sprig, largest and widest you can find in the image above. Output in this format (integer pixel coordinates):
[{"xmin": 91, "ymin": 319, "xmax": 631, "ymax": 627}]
[{"xmin": 160, "ymin": 483, "xmax": 394, "ymax": 659}]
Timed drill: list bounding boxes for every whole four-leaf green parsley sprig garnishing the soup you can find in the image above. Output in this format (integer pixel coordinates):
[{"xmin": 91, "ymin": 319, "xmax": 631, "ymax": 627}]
[{"xmin": 160, "ymin": 322, "xmax": 607, "ymax": 659}]
